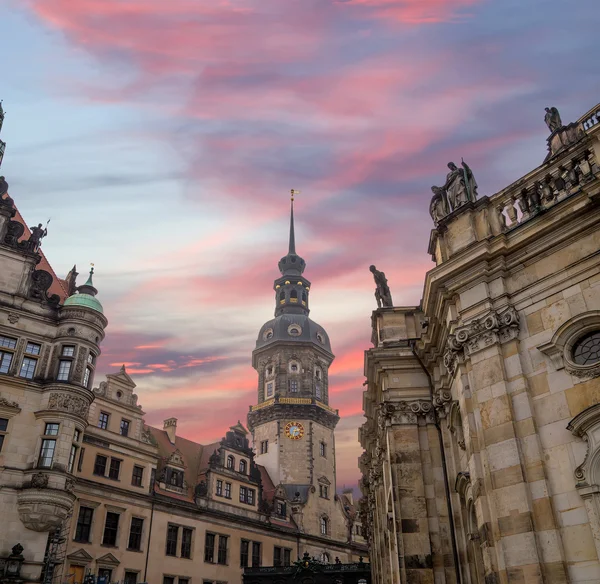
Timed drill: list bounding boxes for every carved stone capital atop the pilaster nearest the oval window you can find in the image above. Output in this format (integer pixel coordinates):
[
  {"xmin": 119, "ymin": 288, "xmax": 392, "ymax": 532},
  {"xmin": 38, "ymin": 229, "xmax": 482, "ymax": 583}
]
[{"xmin": 444, "ymin": 306, "xmax": 519, "ymax": 375}]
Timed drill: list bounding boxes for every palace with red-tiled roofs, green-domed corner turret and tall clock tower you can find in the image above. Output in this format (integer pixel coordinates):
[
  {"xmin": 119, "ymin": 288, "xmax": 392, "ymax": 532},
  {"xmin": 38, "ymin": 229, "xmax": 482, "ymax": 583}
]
[{"xmin": 0, "ymin": 162, "xmax": 367, "ymax": 584}]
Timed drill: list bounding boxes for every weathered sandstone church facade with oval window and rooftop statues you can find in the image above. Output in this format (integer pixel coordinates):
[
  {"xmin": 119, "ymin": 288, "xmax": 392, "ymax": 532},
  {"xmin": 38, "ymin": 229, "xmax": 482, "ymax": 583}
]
[{"xmin": 359, "ymin": 100, "xmax": 600, "ymax": 584}]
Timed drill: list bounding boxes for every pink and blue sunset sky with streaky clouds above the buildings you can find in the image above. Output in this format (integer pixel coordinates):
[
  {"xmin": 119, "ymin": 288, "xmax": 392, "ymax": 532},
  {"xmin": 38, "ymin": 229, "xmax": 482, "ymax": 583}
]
[{"xmin": 0, "ymin": 0, "xmax": 600, "ymax": 488}]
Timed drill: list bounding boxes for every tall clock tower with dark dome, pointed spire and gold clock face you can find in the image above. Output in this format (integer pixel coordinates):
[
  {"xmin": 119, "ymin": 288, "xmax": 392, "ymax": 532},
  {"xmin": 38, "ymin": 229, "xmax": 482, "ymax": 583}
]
[{"xmin": 248, "ymin": 191, "xmax": 339, "ymax": 535}]
